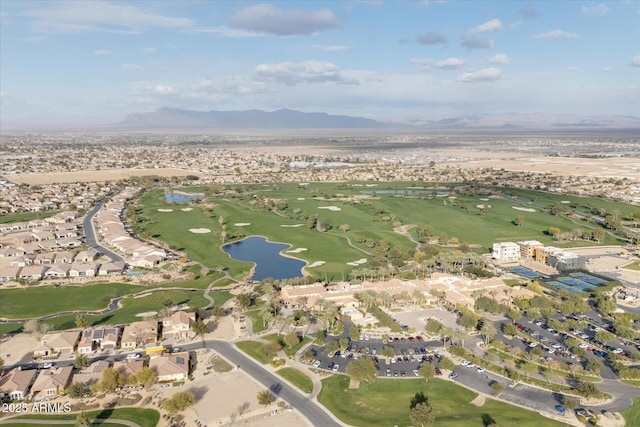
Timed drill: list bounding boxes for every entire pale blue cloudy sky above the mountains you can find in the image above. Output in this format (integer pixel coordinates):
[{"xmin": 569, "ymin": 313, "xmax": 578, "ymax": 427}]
[{"xmin": 0, "ymin": 0, "xmax": 640, "ymax": 123}]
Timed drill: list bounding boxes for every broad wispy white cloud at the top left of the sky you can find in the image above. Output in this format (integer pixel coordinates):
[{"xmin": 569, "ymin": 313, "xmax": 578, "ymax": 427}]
[{"xmin": 24, "ymin": 1, "xmax": 193, "ymax": 34}]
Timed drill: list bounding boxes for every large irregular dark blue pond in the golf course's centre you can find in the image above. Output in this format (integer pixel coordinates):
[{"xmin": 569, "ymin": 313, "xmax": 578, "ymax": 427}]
[{"xmin": 222, "ymin": 236, "xmax": 305, "ymax": 281}]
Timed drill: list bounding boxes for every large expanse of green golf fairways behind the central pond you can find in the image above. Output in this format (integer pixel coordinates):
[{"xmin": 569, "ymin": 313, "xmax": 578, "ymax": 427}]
[{"xmin": 137, "ymin": 182, "xmax": 639, "ymax": 280}]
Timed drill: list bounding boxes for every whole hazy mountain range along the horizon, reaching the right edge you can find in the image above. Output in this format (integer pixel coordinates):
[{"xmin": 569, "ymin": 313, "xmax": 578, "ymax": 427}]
[{"xmin": 113, "ymin": 108, "xmax": 640, "ymax": 130}]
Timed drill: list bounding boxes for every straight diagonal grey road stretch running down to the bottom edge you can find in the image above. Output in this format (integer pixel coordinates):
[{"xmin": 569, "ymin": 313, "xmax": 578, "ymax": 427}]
[{"xmin": 205, "ymin": 340, "xmax": 342, "ymax": 427}]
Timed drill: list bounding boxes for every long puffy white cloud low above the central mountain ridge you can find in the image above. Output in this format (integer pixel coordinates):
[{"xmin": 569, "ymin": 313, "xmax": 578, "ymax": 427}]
[{"xmin": 255, "ymin": 61, "xmax": 358, "ymax": 86}]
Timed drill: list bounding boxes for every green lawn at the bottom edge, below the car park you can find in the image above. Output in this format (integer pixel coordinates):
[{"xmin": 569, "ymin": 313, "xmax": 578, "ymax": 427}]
[{"xmin": 318, "ymin": 375, "xmax": 565, "ymax": 427}]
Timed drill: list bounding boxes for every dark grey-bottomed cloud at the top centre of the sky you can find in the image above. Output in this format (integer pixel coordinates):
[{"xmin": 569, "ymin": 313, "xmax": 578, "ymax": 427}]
[{"xmin": 229, "ymin": 4, "xmax": 340, "ymax": 36}]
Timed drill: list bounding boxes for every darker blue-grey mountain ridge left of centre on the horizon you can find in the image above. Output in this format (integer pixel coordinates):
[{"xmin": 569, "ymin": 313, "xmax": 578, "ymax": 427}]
[{"xmin": 115, "ymin": 108, "xmax": 392, "ymax": 129}]
